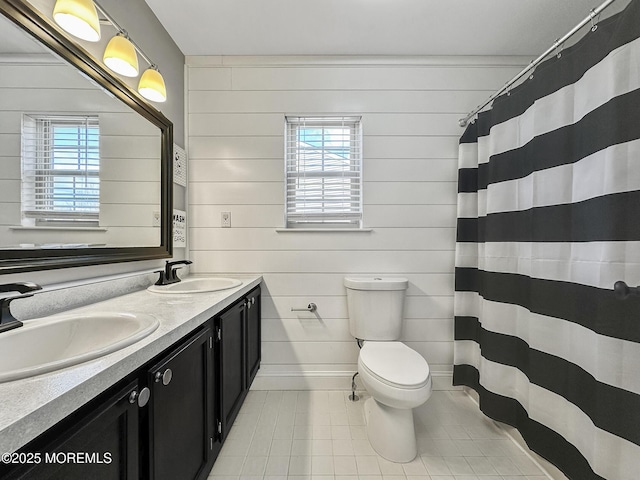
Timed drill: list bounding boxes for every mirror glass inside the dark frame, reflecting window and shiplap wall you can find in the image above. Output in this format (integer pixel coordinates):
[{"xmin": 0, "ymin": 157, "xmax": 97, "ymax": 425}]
[{"xmin": 0, "ymin": 9, "xmax": 163, "ymax": 250}]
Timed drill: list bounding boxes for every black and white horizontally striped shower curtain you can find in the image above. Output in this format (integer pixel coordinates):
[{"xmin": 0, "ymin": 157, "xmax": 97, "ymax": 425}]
[{"xmin": 454, "ymin": 0, "xmax": 640, "ymax": 480}]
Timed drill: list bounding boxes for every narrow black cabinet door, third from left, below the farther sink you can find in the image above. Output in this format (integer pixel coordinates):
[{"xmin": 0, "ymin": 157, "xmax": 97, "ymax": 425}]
[{"xmin": 216, "ymin": 300, "xmax": 246, "ymax": 439}]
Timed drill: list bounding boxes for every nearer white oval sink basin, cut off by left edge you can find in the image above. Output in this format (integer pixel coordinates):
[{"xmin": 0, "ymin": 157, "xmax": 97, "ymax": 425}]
[{"xmin": 0, "ymin": 313, "xmax": 160, "ymax": 382}]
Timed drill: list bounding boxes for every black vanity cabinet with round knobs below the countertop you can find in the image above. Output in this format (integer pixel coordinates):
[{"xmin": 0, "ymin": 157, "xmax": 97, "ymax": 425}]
[{"xmin": 0, "ymin": 287, "xmax": 261, "ymax": 480}]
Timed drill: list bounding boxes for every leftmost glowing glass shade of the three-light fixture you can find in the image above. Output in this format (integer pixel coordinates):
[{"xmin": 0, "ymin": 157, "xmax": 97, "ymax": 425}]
[{"xmin": 53, "ymin": 0, "xmax": 100, "ymax": 42}]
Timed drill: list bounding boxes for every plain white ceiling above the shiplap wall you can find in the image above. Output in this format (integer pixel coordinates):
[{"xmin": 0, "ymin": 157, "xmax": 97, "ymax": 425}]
[{"xmin": 141, "ymin": 0, "xmax": 628, "ymax": 56}]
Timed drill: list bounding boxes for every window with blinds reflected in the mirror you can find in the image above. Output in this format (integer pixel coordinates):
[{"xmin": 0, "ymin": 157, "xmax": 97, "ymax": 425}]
[{"xmin": 22, "ymin": 115, "xmax": 100, "ymax": 226}]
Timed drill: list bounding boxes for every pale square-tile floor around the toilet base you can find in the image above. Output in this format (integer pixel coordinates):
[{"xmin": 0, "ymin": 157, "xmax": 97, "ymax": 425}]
[{"xmin": 209, "ymin": 391, "xmax": 548, "ymax": 480}]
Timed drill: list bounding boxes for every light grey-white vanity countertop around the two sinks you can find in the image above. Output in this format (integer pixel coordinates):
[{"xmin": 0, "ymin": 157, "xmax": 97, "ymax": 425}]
[{"xmin": 0, "ymin": 275, "xmax": 262, "ymax": 453}]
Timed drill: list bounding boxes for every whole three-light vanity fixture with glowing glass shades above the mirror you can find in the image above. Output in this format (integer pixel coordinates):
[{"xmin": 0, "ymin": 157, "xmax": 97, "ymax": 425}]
[{"xmin": 53, "ymin": 0, "xmax": 167, "ymax": 103}]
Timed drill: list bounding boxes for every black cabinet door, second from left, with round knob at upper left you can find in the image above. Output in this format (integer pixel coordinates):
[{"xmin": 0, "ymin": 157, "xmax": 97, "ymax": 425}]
[{"xmin": 147, "ymin": 328, "xmax": 213, "ymax": 480}]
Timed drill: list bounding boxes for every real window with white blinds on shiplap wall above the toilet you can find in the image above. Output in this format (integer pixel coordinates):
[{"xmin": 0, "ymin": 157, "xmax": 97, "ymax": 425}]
[{"xmin": 285, "ymin": 117, "xmax": 362, "ymax": 228}]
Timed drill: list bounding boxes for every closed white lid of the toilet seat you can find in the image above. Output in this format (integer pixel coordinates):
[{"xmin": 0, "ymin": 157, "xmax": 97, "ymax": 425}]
[{"xmin": 360, "ymin": 342, "xmax": 429, "ymax": 388}]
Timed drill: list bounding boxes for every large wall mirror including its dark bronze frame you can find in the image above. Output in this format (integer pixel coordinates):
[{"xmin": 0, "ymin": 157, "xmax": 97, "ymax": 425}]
[{"xmin": 0, "ymin": 0, "xmax": 173, "ymax": 273}]
